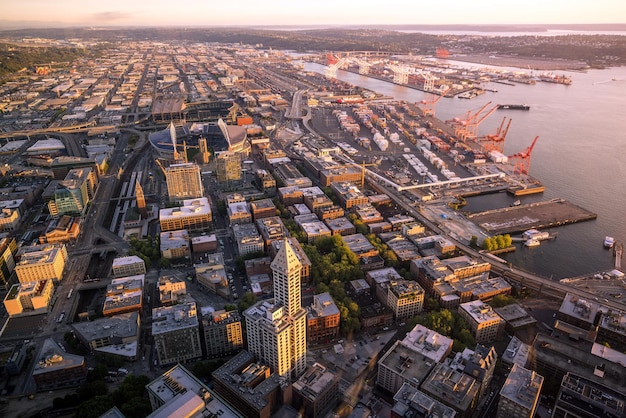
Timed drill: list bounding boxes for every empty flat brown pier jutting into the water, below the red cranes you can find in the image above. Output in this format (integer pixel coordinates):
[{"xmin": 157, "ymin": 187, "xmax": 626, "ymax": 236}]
[{"xmin": 467, "ymin": 199, "xmax": 598, "ymax": 235}]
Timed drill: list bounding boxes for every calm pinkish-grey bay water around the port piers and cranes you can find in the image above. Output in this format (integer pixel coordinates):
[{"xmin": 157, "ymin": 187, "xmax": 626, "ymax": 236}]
[{"xmin": 305, "ymin": 63, "xmax": 626, "ymax": 279}]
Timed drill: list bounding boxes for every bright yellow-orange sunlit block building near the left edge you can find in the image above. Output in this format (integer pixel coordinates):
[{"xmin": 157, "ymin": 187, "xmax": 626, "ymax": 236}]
[{"xmin": 15, "ymin": 244, "xmax": 67, "ymax": 283}]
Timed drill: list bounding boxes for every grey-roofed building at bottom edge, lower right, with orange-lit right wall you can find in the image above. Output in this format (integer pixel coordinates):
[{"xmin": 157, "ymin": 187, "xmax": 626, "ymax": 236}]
[{"xmin": 496, "ymin": 364, "xmax": 543, "ymax": 418}]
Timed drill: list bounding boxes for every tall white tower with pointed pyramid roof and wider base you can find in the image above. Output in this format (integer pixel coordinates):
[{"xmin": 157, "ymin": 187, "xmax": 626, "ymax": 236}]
[{"xmin": 244, "ymin": 240, "xmax": 306, "ymax": 381}]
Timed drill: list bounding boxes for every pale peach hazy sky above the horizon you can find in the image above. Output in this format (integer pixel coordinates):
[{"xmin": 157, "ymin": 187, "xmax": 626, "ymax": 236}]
[{"xmin": 0, "ymin": 0, "xmax": 626, "ymax": 28}]
